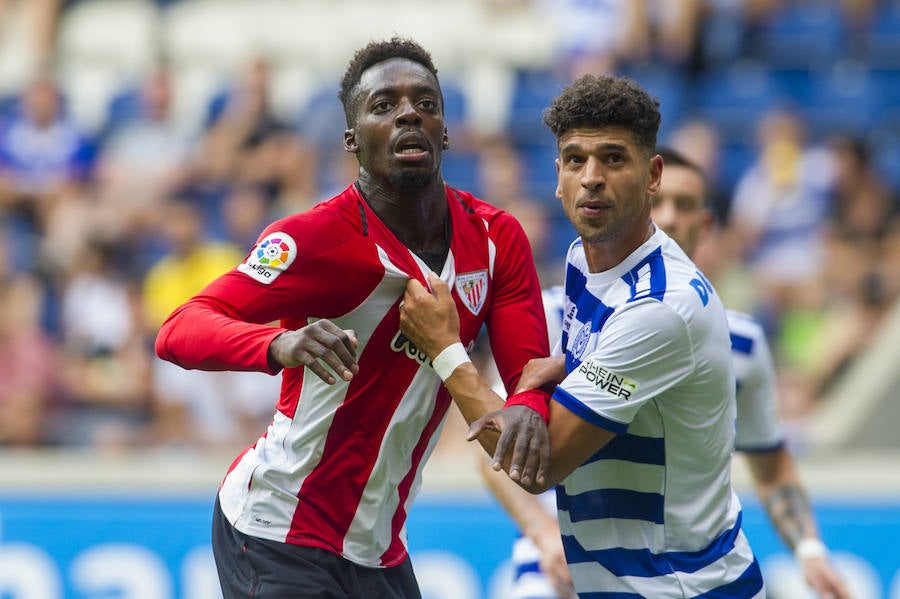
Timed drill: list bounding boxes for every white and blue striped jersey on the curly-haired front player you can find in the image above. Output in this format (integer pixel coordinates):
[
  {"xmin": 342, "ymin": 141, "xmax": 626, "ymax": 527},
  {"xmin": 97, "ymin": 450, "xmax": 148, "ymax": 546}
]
[{"xmin": 553, "ymin": 230, "xmax": 764, "ymax": 599}]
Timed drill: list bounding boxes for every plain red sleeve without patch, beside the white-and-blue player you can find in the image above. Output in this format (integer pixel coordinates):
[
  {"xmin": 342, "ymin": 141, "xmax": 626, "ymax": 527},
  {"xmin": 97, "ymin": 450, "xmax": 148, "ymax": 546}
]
[{"xmin": 486, "ymin": 213, "xmax": 550, "ymax": 403}]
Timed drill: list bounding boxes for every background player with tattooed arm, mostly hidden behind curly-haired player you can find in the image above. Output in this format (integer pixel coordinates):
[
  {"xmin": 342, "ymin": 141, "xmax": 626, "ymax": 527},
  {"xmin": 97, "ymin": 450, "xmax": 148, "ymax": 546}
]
[{"xmin": 482, "ymin": 148, "xmax": 849, "ymax": 599}]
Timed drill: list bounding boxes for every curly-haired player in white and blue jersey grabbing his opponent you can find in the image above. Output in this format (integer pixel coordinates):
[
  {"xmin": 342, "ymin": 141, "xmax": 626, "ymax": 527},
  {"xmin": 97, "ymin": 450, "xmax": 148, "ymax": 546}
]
[{"xmin": 401, "ymin": 75, "xmax": 765, "ymax": 598}]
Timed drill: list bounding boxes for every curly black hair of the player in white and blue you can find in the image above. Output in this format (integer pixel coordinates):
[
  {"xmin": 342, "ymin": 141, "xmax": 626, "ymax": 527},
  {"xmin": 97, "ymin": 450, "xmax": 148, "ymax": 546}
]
[{"xmin": 543, "ymin": 75, "xmax": 661, "ymax": 154}]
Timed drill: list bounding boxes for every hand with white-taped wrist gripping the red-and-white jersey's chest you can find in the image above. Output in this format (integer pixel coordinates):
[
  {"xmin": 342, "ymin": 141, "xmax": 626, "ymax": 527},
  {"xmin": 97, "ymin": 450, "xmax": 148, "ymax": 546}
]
[{"xmin": 400, "ymin": 273, "xmax": 459, "ymax": 359}]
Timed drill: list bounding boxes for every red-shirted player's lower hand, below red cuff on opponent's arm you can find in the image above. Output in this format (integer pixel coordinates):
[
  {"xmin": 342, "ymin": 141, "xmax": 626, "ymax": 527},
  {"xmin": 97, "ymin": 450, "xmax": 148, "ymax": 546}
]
[{"xmin": 467, "ymin": 405, "xmax": 550, "ymax": 490}]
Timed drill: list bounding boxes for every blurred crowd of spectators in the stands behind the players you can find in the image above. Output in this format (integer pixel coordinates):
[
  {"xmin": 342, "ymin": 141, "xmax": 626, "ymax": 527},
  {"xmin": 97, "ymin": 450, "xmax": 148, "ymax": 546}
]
[{"xmin": 0, "ymin": 0, "xmax": 900, "ymax": 449}]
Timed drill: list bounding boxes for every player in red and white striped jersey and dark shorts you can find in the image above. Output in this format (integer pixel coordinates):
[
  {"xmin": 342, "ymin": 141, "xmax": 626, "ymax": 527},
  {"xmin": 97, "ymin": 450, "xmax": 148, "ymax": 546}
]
[{"xmin": 156, "ymin": 38, "xmax": 549, "ymax": 599}]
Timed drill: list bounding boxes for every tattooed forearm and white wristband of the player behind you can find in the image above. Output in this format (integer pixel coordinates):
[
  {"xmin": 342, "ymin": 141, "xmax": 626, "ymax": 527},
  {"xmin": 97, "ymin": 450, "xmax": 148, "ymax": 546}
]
[{"xmin": 745, "ymin": 447, "xmax": 851, "ymax": 599}]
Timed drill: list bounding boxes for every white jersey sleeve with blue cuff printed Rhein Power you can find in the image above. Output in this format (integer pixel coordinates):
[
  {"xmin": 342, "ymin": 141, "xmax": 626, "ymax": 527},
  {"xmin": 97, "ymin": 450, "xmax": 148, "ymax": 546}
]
[{"xmin": 553, "ymin": 299, "xmax": 695, "ymax": 434}]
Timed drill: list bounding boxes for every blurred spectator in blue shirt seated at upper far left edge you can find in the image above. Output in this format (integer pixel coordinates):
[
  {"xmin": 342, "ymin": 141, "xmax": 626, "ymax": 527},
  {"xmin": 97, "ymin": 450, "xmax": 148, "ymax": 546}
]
[{"xmin": 0, "ymin": 71, "xmax": 93, "ymax": 269}]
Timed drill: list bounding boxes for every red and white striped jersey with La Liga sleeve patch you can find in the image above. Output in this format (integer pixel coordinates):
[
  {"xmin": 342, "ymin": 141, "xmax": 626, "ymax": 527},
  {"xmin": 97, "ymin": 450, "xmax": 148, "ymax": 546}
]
[{"xmin": 156, "ymin": 186, "xmax": 549, "ymax": 566}]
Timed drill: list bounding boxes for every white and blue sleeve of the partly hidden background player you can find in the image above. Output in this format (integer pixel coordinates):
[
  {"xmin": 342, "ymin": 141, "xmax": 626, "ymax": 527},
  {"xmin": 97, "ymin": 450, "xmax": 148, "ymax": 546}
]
[{"xmin": 729, "ymin": 316, "xmax": 784, "ymax": 451}]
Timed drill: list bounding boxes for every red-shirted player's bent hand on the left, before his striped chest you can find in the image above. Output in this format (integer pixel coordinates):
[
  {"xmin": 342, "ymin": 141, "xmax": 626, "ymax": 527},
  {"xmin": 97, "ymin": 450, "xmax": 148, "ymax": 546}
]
[{"xmin": 269, "ymin": 320, "xmax": 359, "ymax": 385}]
